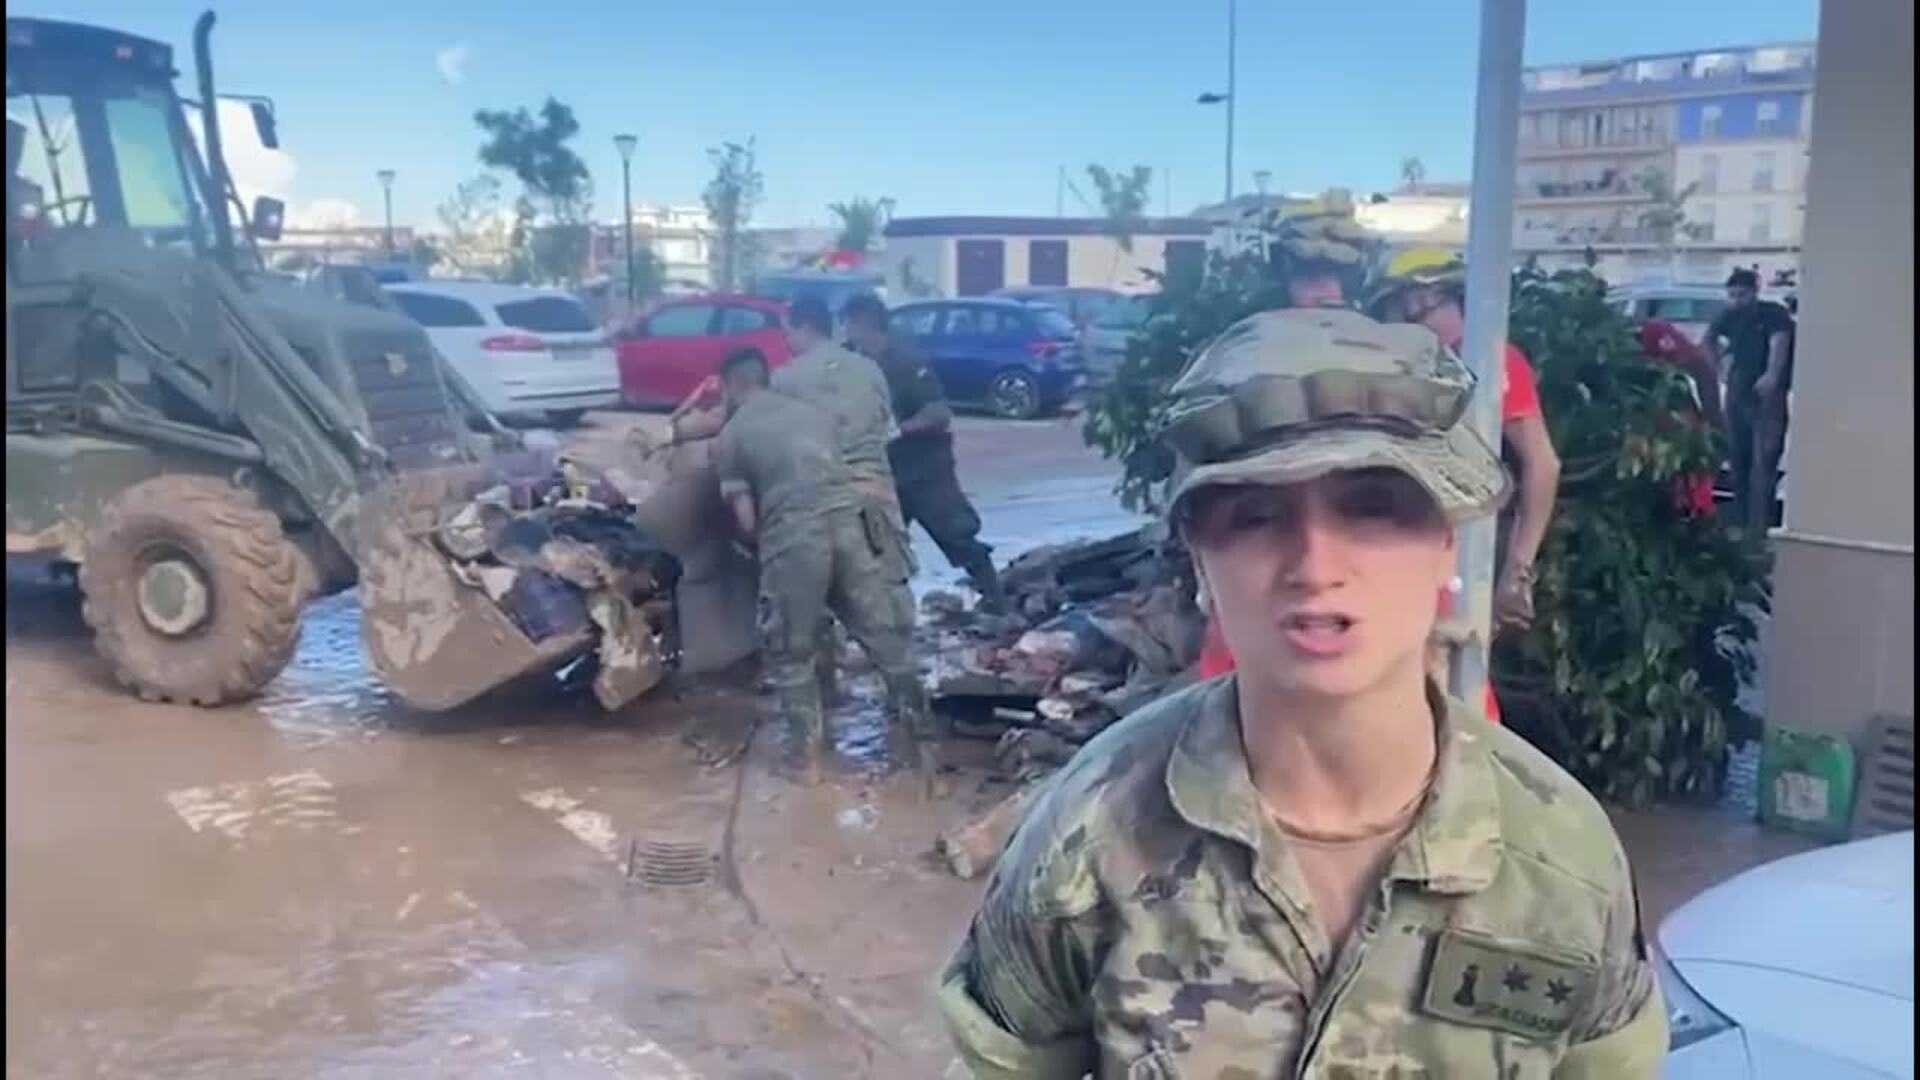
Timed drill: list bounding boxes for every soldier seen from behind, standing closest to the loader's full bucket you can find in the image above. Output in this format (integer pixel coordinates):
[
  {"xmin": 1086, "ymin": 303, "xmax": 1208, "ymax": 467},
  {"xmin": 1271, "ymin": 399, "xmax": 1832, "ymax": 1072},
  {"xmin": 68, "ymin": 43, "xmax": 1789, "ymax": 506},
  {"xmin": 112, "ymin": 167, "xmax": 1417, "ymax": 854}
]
[{"xmin": 714, "ymin": 350, "xmax": 935, "ymax": 786}]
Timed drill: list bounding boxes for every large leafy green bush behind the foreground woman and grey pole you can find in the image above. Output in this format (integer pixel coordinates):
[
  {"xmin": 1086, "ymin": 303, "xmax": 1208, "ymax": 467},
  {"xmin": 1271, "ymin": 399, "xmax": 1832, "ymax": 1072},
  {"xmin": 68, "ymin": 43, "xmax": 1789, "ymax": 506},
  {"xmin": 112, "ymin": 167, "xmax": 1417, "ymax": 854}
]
[{"xmin": 1085, "ymin": 252, "xmax": 1768, "ymax": 803}]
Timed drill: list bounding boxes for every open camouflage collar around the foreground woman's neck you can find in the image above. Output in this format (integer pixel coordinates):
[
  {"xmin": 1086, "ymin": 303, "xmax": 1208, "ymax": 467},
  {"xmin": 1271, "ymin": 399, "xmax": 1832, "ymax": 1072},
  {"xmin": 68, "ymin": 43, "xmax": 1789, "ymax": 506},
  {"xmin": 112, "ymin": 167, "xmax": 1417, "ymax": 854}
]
[{"xmin": 1165, "ymin": 678, "xmax": 1501, "ymax": 894}]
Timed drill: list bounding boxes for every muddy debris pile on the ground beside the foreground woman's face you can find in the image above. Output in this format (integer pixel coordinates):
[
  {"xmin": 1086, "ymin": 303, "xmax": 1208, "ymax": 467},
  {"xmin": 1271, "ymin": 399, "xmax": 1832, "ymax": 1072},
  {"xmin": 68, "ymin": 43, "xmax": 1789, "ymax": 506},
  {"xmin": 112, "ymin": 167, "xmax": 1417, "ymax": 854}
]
[{"xmin": 922, "ymin": 527, "xmax": 1206, "ymax": 876}]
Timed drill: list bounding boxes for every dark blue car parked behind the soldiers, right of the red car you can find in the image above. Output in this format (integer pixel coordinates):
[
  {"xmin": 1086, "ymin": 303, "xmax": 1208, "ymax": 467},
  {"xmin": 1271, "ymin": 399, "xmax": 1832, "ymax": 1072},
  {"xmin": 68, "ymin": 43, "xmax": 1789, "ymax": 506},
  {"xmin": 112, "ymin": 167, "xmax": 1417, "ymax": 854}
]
[{"xmin": 891, "ymin": 300, "xmax": 1087, "ymax": 419}]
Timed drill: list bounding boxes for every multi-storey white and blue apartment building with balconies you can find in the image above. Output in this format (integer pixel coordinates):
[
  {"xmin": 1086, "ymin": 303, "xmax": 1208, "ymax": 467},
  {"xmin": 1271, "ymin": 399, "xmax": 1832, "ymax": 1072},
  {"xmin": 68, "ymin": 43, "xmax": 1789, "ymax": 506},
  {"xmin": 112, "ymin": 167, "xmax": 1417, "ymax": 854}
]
[{"xmin": 1515, "ymin": 42, "xmax": 1814, "ymax": 282}]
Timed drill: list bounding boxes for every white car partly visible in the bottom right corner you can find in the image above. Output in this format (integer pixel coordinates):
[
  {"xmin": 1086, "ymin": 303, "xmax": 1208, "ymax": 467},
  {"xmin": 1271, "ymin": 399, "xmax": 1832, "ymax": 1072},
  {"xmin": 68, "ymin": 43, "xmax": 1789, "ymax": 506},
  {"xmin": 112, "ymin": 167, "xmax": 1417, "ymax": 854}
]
[{"xmin": 1657, "ymin": 830, "xmax": 1914, "ymax": 1080}]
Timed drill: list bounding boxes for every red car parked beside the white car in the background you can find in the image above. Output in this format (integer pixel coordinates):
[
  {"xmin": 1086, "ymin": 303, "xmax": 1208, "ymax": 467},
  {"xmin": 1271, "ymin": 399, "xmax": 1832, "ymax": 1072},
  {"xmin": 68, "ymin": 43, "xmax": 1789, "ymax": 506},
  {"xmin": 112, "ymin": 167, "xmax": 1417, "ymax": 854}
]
[{"xmin": 614, "ymin": 294, "xmax": 793, "ymax": 407}]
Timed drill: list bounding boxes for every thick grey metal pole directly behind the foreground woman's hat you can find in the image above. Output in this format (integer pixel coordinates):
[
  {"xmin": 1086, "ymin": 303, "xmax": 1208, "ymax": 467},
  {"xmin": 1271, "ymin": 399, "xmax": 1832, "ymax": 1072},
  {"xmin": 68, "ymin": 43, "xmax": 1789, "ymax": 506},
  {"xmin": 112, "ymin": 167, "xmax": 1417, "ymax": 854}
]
[{"xmin": 1450, "ymin": 0, "xmax": 1526, "ymax": 703}]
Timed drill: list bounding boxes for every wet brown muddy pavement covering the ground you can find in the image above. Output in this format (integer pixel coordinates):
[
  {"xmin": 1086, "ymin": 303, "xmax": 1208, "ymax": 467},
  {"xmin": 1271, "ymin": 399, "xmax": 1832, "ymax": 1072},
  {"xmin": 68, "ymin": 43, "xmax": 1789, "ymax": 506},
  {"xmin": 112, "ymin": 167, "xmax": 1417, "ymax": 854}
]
[{"xmin": 6, "ymin": 407, "xmax": 1803, "ymax": 1080}]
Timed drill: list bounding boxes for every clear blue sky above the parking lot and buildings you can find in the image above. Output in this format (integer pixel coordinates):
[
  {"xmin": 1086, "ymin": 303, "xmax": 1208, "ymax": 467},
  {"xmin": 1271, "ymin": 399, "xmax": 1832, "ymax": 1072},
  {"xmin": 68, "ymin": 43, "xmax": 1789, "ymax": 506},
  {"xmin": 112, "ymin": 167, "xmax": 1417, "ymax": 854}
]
[{"xmin": 26, "ymin": 0, "xmax": 1818, "ymax": 225}]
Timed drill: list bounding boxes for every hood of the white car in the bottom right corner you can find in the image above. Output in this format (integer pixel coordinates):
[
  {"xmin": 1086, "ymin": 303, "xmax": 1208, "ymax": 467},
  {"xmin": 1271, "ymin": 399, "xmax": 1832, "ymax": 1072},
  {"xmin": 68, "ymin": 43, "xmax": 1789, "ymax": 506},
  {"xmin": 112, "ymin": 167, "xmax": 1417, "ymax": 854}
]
[{"xmin": 1659, "ymin": 830, "xmax": 1914, "ymax": 999}]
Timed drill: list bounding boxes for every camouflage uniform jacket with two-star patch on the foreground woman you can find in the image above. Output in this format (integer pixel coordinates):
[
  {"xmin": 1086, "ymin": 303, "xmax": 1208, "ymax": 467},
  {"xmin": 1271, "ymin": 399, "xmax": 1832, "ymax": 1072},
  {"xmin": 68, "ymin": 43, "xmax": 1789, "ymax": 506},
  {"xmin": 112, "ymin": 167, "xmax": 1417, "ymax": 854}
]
[{"xmin": 939, "ymin": 676, "xmax": 1667, "ymax": 1080}]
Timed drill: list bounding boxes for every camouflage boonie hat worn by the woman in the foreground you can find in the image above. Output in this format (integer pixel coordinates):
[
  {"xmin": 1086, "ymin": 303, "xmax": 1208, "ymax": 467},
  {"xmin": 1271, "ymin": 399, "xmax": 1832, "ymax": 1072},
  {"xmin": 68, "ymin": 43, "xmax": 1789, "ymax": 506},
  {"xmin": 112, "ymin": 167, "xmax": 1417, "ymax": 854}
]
[{"xmin": 1162, "ymin": 307, "xmax": 1507, "ymax": 521}]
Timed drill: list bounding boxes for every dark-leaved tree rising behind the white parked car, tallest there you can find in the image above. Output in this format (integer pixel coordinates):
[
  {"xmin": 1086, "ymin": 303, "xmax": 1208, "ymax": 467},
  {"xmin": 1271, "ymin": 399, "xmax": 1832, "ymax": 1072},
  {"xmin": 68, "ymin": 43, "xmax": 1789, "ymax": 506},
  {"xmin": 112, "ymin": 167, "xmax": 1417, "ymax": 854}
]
[{"xmin": 474, "ymin": 98, "xmax": 593, "ymax": 284}]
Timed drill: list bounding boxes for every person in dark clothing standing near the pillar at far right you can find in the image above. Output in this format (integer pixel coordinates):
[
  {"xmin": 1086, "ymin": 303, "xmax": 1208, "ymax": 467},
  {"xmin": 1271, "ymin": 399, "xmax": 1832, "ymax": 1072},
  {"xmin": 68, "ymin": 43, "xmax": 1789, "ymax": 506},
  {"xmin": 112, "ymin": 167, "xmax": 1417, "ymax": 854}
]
[{"xmin": 1701, "ymin": 269, "xmax": 1793, "ymax": 532}]
